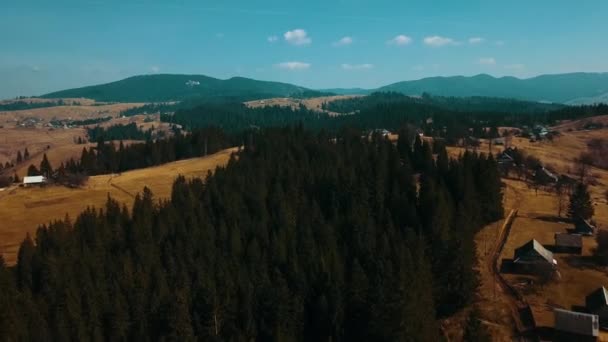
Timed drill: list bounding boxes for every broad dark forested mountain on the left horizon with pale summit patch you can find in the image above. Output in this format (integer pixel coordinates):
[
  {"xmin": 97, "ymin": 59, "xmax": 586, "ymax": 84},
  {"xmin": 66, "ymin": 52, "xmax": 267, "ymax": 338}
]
[{"xmin": 42, "ymin": 74, "xmax": 330, "ymax": 102}]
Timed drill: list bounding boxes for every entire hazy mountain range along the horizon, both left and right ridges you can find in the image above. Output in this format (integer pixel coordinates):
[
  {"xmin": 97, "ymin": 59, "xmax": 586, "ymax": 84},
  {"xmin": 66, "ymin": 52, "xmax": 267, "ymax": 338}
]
[{"xmin": 42, "ymin": 72, "xmax": 608, "ymax": 104}]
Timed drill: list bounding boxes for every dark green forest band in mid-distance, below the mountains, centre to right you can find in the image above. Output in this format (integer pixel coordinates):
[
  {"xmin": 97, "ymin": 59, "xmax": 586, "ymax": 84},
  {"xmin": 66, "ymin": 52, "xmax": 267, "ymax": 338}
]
[{"xmin": 161, "ymin": 93, "xmax": 608, "ymax": 139}]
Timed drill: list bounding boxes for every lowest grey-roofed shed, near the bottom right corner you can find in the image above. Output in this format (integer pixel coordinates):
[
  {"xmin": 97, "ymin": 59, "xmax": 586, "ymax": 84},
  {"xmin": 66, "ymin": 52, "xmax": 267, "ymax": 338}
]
[{"xmin": 553, "ymin": 309, "xmax": 599, "ymax": 341}]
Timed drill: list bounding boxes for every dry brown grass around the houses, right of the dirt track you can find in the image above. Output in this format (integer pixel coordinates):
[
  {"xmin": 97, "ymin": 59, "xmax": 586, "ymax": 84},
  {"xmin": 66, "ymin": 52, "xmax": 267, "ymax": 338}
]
[{"xmin": 501, "ymin": 180, "xmax": 608, "ymax": 336}]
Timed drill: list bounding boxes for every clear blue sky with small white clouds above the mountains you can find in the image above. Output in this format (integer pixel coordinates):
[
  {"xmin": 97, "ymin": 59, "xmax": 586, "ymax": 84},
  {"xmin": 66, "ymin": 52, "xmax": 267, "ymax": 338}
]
[{"xmin": 0, "ymin": 0, "xmax": 608, "ymax": 98}]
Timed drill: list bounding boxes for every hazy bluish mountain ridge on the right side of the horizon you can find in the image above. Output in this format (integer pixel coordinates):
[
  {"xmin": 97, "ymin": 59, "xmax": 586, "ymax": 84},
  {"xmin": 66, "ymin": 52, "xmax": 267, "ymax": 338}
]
[{"xmin": 377, "ymin": 73, "xmax": 608, "ymax": 104}]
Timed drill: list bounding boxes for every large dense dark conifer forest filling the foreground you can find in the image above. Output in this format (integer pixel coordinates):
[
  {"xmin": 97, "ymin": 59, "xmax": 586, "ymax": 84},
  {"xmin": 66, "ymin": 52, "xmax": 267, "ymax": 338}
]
[{"xmin": 0, "ymin": 128, "xmax": 503, "ymax": 342}]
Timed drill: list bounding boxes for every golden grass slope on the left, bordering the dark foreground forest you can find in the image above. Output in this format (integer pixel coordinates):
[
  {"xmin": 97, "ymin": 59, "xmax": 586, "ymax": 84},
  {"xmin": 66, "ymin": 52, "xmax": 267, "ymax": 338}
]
[{"xmin": 0, "ymin": 148, "xmax": 236, "ymax": 264}]
